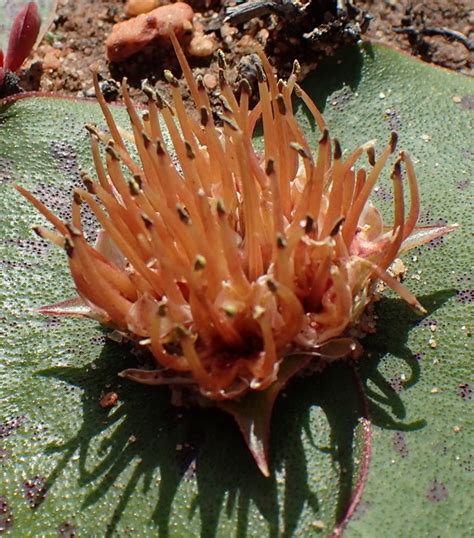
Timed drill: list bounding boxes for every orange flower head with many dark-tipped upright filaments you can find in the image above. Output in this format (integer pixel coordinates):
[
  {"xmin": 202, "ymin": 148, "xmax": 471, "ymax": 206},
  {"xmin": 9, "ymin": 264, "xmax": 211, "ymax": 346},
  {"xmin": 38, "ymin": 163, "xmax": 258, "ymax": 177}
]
[{"xmin": 17, "ymin": 36, "xmax": 453, "ymax": 400}]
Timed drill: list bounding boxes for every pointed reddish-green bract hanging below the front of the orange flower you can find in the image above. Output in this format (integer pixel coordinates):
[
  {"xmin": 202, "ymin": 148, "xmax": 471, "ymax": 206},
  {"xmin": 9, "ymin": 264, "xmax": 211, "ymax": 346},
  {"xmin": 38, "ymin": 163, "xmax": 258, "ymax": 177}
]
[{"xmin": 217, "ymin": 355, "xmax": 311, "ymax": 476}]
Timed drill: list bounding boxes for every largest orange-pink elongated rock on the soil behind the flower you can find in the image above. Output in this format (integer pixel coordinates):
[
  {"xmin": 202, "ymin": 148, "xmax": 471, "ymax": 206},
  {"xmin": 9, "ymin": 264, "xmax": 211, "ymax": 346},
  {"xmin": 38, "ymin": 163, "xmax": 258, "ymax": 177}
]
[{"xmin": 105, "ymin": 2, "xmax": 194, "ymax": 62}]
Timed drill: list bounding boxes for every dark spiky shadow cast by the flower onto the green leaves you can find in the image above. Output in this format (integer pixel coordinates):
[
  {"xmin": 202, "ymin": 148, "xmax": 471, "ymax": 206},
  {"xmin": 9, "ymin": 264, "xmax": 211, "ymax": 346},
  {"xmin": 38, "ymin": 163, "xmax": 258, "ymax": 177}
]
[{"xmin": 39, "ymin": 291, "xmax": 453, "ymax": 538}]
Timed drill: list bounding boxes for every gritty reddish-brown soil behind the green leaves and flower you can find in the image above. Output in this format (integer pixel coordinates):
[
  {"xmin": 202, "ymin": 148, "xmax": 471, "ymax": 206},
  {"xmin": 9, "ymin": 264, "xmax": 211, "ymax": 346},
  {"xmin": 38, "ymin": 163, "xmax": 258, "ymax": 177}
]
[{"xmin": 12, "ymin": 0, "xmax": 474, "ymax": 100}]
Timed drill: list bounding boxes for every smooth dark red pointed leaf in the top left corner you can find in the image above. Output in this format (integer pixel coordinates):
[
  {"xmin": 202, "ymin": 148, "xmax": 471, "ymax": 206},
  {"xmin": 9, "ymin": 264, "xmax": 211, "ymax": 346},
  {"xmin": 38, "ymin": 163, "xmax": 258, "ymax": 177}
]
[{"xmin": 5, "ymin": 2, "xmax": 41, "ymax": 71}]
